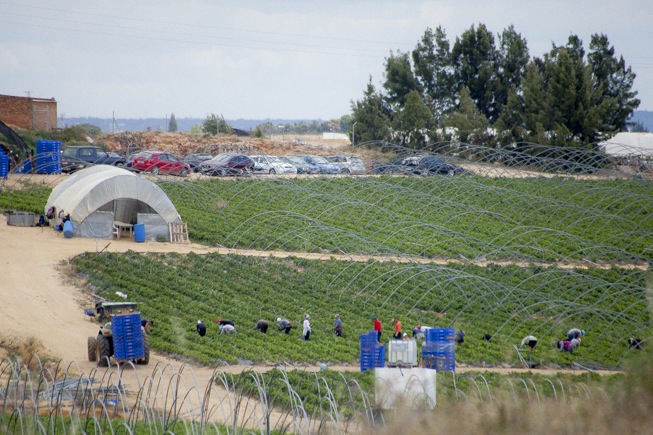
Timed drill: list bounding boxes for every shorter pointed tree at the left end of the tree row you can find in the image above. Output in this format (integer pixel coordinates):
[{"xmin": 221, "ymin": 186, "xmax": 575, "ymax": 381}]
[{"xmin": 351, "ymin": 77, "xmax": 391, "ymax": 143}]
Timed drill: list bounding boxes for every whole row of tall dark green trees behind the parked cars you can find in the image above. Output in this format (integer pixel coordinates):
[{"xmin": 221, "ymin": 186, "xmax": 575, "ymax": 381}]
[{"xmin": 351, "ymin": 24, "xmax": 640, "ymax": 148}]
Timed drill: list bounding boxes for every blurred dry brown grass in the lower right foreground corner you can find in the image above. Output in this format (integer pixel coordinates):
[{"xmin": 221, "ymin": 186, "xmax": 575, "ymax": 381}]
[{"xmin": 368, "ymin": 352, "xmax": 653, "ymax": 435}]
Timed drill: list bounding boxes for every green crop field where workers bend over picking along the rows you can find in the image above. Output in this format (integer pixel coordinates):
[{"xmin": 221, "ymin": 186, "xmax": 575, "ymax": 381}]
[{"xmin": 73, "ymin": 252, "xmax": 651, "ymax": 367}]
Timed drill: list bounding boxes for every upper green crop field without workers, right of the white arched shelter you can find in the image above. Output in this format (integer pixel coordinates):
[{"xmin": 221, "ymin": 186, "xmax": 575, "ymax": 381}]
[{"xmin": 161, "ymin": 177, "xmax": 653, "ymax": 263}]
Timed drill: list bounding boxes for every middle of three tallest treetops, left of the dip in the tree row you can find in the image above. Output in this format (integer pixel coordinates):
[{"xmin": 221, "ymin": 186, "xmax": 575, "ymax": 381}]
[{"xmin": 451, "ymin": 24, "xmax": 499, "ymax": 122}]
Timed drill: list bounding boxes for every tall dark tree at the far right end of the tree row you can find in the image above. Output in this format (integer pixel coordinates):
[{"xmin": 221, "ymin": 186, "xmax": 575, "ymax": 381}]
[{"xmin": 587, "ymin": 34, "xmax": 640, "ymax": 132}]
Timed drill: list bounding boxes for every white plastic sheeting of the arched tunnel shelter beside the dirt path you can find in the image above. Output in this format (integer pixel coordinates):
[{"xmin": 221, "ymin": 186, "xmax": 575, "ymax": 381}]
[{"xmin": 45, "ymin": 165, "xmax": 181, "ymax": 240}]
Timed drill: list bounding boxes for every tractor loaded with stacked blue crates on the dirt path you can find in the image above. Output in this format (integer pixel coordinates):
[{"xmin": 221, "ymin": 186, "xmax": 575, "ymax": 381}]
[{"xmin": 88, "ymin": 302, "xmax": 150, "ymax": 367}]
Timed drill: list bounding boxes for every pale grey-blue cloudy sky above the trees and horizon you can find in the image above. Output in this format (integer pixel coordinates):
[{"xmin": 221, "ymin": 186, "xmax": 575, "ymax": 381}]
[{"xmin": 0, "ymin": 0, "xmax": 653, "ymax": 120}]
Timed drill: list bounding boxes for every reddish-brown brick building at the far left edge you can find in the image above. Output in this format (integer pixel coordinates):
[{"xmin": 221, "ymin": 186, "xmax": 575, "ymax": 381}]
[{"xmin": 0, "ymin": 95, "xmax": 57, "ymax": 131}]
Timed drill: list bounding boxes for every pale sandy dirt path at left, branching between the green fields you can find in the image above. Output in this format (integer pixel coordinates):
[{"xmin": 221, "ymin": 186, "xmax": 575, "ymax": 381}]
[{"xmin": 0, "ymin": 215, "xmax": 620, "ymax": 385}]
